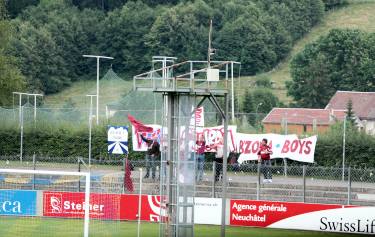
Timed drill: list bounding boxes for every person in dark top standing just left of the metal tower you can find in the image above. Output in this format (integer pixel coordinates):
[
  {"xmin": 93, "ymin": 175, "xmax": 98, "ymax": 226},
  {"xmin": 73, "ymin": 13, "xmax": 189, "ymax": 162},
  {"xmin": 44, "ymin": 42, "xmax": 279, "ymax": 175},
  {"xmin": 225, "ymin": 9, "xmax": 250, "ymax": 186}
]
[{"xmin": 141, "ymin": 134, "xmax": 160, "ymax": 179}]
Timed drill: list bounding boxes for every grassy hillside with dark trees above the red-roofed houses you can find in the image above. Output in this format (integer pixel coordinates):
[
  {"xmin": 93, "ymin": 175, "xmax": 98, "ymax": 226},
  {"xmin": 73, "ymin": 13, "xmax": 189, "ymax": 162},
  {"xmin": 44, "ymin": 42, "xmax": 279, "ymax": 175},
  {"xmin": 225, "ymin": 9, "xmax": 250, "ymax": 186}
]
[{"xmin": 247, "ymin": 0, "xmax": 375, "ymax": 103}]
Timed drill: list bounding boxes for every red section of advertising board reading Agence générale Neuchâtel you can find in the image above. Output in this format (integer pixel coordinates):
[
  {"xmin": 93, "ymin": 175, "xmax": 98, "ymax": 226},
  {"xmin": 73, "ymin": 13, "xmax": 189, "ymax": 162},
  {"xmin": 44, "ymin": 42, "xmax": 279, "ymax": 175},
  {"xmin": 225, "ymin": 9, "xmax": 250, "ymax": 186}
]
[{"xmin": 230, "ymin": 200, "xmax": 343, "ymax": 227}]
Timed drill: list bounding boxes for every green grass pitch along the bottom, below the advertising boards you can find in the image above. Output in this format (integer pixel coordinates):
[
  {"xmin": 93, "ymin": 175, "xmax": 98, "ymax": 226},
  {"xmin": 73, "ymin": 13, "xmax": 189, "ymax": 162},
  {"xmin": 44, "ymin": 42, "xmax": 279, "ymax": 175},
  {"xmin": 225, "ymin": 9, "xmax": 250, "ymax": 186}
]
[{"xmin": 0, "ymin": 217, "xmax": 360, "ymax": 237}]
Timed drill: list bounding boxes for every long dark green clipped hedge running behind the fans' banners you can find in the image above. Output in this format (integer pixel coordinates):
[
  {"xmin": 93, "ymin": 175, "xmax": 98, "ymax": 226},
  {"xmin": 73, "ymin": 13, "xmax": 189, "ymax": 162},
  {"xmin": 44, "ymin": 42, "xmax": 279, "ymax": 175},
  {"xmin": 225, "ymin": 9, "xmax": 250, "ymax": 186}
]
[{"xmin": 0, "ymin": 127, "xmax": 375, "ymax": 167}]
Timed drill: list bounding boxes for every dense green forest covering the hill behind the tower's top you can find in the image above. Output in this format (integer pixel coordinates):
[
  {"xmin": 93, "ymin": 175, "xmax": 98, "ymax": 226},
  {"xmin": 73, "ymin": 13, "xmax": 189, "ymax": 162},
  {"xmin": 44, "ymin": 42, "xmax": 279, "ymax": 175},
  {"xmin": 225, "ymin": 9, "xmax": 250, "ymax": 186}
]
[{"xmin": 0, "ymin": 0, "xmax": 324, "ymax": 100}]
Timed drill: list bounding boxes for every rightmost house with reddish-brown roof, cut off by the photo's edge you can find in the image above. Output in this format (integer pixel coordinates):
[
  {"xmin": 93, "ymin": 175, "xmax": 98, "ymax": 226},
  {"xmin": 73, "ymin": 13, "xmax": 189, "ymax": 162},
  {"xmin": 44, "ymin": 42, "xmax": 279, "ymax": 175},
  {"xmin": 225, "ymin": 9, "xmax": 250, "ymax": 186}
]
[{"xmin": 326, "ymin": 91, "xmax": 375, "ymax": 135}]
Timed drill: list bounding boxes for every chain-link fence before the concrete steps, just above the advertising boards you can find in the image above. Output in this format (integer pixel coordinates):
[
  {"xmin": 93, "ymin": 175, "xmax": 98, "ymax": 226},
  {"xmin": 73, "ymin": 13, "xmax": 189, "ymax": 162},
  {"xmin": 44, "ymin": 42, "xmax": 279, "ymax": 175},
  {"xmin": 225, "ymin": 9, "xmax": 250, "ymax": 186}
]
[{"xmin": 0, "ymin": 156, "xmax": 375, "ymax": 206}]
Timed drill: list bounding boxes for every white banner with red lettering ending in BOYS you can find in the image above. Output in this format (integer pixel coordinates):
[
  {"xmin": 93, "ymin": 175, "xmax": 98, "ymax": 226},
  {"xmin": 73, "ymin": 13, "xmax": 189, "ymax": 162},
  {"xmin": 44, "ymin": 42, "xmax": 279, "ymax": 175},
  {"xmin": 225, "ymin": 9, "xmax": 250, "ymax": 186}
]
[{"xmin": 236, "ymin": 133, "xmax": 317, "ymax": 163}]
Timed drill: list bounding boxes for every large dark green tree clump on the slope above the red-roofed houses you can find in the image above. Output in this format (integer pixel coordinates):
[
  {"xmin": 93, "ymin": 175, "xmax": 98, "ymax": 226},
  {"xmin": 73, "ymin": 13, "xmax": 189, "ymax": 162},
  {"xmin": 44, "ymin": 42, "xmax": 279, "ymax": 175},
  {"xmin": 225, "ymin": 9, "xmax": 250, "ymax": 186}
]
[{"xmin": 287, "ymin": 29, "xmax": 375, "ymax": 108}]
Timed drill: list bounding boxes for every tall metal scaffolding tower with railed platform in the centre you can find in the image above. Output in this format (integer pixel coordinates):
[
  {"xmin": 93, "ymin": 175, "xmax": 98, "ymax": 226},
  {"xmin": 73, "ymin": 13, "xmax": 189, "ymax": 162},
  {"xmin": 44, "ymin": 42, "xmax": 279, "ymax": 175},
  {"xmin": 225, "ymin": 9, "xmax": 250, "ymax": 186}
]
[{"xmin": 133, "ymin": 56, "xmax": 239, "ymax": 237}]
